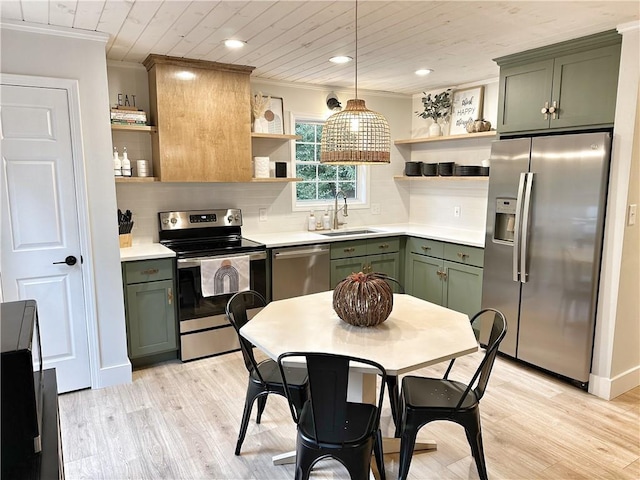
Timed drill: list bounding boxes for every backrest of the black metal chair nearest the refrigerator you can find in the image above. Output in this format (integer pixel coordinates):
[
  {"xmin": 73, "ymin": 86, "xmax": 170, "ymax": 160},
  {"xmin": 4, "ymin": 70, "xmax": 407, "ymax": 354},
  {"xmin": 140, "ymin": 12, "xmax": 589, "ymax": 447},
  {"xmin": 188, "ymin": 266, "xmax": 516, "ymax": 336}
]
[{"xmin": 444, "ymin": 308, "xmax": 507, "ymax": 408}]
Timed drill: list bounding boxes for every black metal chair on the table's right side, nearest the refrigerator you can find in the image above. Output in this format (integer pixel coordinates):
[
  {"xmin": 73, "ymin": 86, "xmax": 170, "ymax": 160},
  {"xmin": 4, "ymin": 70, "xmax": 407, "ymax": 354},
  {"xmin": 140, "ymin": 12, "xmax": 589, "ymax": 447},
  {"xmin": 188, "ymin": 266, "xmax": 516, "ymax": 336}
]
[{"xmin": 398, "ymin": 308, "xmax": 507, "ymax": 480}]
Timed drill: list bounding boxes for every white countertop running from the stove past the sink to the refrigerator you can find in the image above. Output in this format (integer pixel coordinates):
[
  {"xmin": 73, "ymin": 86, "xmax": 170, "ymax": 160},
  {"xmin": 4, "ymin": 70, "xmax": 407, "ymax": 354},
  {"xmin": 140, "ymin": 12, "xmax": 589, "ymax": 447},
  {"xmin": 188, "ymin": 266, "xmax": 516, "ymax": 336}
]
[{"xmin": 242, "ymin": 223, "xmax": 485, "ymax": 248}]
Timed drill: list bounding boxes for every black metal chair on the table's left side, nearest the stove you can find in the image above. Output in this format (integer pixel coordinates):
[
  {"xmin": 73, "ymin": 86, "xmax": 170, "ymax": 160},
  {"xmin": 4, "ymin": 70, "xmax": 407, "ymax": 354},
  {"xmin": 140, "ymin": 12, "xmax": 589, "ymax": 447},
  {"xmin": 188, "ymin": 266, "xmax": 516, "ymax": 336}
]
[{"xmin": 226, "ymin": 290, "xmax": 308, "ymax": 455}]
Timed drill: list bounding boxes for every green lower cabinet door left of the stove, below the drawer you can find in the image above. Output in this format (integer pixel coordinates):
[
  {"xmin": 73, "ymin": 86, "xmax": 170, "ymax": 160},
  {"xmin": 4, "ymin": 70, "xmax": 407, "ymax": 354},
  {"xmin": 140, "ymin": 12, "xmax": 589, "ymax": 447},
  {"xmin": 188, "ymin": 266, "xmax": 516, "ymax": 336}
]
[{"xmin": 126, "ymin": 280, "xmax": 178, "ymax": 358}]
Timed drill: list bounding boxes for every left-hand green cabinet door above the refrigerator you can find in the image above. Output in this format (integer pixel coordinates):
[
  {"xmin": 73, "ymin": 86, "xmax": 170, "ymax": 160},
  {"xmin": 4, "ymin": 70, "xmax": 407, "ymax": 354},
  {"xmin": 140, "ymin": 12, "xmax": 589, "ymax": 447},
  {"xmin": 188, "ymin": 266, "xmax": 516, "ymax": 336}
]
[{"xmin": 497, "ymin": 60, "xmax": 553, "ymax": 133}]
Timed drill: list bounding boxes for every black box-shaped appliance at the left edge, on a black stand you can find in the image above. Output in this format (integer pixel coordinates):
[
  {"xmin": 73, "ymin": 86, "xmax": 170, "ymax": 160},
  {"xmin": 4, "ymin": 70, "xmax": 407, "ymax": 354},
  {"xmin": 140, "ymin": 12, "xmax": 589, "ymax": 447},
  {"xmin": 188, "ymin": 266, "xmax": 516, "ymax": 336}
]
[{"xmin": 0, "ymin": 300, "xmax": 43, "ymax": 470}]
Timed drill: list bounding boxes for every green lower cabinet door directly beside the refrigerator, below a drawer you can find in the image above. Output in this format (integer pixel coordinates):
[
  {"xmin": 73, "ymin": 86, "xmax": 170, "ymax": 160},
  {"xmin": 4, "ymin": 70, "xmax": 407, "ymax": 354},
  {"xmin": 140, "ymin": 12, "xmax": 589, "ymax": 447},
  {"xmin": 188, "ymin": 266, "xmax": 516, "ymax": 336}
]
[{"xmin": 443, "ymin": 261, "xmax": 482, "ymax": 316}]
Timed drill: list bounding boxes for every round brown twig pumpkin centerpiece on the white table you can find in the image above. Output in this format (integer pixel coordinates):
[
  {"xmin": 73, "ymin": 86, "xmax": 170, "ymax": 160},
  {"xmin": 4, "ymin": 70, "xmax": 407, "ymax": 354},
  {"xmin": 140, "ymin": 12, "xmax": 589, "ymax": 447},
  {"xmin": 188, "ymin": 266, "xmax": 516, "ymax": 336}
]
[{"xmin": 333, "ymin": 272, "xmax": 393, "ymax": 327}]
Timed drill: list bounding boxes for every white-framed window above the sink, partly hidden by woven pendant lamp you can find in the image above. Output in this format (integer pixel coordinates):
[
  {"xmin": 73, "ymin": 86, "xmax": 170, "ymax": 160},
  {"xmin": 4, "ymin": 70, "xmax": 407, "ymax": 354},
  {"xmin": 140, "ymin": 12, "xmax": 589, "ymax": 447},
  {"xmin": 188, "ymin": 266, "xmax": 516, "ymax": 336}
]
[{"xmin": 295, "ymin": 119, "xmax": 366, "ymax": 209}]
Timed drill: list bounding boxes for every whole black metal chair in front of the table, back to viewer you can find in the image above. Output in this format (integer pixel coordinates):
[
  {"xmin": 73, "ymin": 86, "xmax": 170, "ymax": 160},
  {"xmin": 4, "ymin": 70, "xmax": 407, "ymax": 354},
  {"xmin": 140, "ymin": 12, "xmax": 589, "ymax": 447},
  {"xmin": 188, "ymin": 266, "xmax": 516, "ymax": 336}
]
[{"xmin": 278, "ymin": 352, "xmax": 386, "ymax": 480}]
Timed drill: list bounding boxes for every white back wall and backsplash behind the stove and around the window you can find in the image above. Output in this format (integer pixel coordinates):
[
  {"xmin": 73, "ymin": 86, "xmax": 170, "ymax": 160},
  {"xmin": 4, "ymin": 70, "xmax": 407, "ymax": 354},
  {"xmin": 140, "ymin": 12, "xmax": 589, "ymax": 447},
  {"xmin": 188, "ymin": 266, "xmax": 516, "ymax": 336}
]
[{"xmin": 108, "ymin": 62, "xmax": 411, "ymax": 244}]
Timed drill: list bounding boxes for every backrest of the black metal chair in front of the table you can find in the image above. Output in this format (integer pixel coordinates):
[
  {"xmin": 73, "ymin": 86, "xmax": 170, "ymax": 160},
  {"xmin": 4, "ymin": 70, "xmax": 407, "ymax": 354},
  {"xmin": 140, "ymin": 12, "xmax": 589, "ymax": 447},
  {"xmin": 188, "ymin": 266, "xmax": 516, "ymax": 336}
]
[{"xmin": 278, "ymin": 352, "xmax": 387, "ymax": 444}]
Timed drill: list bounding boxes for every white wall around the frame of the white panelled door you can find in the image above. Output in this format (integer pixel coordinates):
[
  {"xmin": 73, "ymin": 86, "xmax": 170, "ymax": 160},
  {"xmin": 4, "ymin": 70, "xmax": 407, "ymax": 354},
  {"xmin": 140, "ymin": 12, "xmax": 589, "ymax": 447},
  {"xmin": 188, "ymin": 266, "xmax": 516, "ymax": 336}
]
[{"xmin": 0, "ymin": 22, "xmax": 131, "ymax": 387}]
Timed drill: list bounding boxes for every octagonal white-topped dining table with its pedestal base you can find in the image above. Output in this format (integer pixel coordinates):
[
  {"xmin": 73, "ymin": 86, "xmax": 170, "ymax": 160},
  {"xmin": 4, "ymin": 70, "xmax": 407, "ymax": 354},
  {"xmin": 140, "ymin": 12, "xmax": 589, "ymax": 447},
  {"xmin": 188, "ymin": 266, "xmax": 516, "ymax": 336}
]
[{"xmin": 240, "ymin": 291, "xmax": 478, "ymax": 464}]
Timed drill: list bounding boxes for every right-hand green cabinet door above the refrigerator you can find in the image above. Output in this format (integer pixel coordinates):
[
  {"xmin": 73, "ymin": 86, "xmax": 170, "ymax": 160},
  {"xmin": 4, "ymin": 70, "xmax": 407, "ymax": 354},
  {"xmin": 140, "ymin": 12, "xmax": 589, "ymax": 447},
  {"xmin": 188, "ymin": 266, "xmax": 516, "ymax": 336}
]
[{"xmin": 550, "ymin": 45, "xmax": 620, "ymax": 128}]
